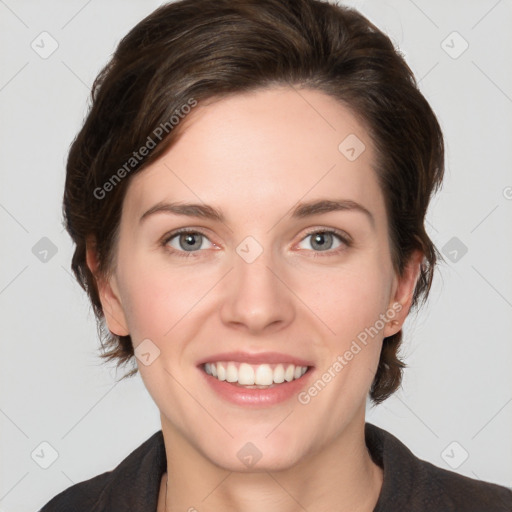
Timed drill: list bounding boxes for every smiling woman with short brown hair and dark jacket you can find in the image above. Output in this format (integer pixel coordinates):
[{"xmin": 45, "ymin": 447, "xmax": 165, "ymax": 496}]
[{"xmin": 42, "ymin": 0, "xmax": 512, "ymax": 512}]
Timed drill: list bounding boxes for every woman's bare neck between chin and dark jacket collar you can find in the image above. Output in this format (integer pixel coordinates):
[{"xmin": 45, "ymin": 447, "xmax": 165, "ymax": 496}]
[{"xmin": 158, "ymin": 414, "xmax": 383, "ymax": 512}]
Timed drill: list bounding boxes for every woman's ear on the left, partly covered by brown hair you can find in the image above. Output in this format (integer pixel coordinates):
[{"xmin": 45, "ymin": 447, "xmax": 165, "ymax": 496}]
[{"xmin": 85, "ymin": 238, "xmax": 130, "ymax": 336}]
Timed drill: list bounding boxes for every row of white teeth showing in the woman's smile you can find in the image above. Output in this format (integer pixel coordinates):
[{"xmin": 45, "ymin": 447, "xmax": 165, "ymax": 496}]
[{"xmin": 204, "ymin": 361, "xmax": 308, "ymax": 386}]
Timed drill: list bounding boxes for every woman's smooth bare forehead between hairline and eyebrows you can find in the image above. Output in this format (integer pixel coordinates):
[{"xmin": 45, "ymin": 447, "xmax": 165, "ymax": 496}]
[{"xmin": 125, "ymin": 87, "xmax": 384, "ymax": 226}]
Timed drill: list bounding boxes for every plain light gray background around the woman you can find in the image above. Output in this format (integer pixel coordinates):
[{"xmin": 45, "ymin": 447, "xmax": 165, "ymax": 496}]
[{"xmin": 0, "ymin": 0, "xmax": 512, "ymax": 511}]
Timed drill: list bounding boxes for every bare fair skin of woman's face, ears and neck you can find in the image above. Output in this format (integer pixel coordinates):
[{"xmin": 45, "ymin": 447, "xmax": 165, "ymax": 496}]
[{"xmin": 88, "ymin": 87, "xmax": 422, "ymax": 512}]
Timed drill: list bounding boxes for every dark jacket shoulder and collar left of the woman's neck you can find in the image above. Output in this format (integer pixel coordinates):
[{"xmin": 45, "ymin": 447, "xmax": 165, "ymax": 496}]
[{"xmin": 39, "ymin": 430, "xmax": 167, "ymax": 512}]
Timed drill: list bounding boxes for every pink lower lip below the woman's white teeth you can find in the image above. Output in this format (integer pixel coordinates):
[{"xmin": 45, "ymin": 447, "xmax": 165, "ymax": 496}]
[{"xmin": 199, "ymin": 368, "xmax": 313, "ymax": 407}]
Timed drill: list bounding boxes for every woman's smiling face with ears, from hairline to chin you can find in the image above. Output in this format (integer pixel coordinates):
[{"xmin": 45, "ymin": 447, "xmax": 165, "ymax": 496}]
[{"xmin": 90, "ymin": 87, "xmax": 417, "ymax": 471}]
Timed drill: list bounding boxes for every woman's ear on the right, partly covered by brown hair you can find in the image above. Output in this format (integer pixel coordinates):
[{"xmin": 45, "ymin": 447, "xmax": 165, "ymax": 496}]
[{"xmin": 384, "ymin": 250, "xmax": 423, "ymax": 338}]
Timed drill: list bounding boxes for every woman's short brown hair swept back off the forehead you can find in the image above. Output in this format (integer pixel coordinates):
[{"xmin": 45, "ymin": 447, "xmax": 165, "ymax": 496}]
[{"xmin": 63, "ymin": 0, "xmax": 444, "ymax": 403}]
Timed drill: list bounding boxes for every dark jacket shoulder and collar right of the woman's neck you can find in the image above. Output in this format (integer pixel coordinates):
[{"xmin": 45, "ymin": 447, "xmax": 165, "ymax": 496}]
[{"xmin": 365, "ymin": 423, "xmax": 512, "ymax": 512}]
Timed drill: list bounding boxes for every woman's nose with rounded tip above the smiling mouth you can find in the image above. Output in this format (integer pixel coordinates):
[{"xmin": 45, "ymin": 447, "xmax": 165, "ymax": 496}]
[{"xmin": 220, "ymin": 245, "xmax": 296, "ymax": 335}]
